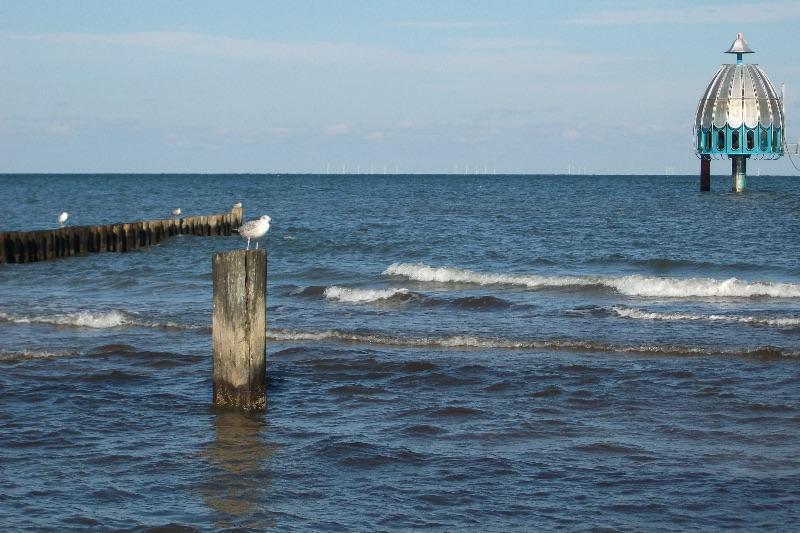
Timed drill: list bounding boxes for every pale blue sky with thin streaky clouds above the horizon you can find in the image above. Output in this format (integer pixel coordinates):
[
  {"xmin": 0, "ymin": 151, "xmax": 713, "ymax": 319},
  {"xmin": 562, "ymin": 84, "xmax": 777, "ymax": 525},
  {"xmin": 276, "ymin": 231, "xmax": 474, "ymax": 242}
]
[{"xmin": 0, "ymin": 0, "xmax": 800, "ymax": 175}]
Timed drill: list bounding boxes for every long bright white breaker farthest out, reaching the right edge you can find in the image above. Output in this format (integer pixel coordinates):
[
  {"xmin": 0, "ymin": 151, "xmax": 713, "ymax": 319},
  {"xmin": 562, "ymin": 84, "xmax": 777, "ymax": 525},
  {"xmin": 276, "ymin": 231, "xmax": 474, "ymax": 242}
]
[{"xmin": 383, "ymin": 263, "xmax": 800, "ymax": 298}]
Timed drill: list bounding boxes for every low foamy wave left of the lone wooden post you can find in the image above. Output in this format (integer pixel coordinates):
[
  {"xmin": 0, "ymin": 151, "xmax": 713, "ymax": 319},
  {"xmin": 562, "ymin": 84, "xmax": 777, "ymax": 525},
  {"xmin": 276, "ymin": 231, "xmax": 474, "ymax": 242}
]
[{"xmin": 0, "ymin": 310, "xmax": 208, "ymax": 330}]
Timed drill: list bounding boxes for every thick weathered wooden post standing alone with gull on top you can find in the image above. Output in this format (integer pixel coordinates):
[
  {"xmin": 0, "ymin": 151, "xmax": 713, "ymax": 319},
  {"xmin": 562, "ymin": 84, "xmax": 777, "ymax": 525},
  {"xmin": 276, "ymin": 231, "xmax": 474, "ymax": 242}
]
[{"xmin": 211, "ymin": 250, "xmax": 267, "ymax": 411}]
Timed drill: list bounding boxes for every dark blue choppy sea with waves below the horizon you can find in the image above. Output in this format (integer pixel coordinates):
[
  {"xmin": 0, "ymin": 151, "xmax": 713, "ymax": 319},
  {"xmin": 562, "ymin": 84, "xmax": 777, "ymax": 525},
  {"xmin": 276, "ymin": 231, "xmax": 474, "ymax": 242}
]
[{"xmin": 0, "ymin": 174, "xmax": 800, "ymax": 532}]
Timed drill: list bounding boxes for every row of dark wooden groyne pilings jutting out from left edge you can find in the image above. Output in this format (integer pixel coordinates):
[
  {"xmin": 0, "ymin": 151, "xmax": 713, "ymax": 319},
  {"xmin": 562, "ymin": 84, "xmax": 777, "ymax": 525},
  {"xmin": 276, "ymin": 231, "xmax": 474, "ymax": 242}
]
[{"xmin": 0, "ymin": 207, "xmax": 242, "ymax": 264}]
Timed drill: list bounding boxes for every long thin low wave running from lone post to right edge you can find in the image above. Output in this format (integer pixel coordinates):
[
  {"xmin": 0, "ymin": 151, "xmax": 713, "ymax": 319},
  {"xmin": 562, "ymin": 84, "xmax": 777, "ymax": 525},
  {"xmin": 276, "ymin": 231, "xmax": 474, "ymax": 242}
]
[{"xmin": 267, "ymin": 329, "xmax": 800, "ymax": 358}]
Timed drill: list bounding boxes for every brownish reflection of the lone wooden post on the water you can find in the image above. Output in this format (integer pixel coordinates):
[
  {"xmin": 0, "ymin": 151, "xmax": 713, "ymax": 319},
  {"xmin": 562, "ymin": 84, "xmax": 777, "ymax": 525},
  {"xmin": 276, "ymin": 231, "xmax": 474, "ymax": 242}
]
[{"xmin": 203, "ymin": 410, "xmax": 276, "ymax": 530}]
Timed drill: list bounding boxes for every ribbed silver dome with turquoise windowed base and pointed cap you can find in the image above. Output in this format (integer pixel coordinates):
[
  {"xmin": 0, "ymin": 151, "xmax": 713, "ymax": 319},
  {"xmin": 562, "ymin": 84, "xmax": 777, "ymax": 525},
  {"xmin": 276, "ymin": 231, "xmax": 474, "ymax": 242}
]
[{"xmin": 694, "ymin": 33, "xmax": 784, "ymax": 159}]
